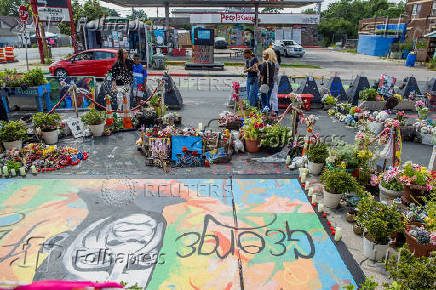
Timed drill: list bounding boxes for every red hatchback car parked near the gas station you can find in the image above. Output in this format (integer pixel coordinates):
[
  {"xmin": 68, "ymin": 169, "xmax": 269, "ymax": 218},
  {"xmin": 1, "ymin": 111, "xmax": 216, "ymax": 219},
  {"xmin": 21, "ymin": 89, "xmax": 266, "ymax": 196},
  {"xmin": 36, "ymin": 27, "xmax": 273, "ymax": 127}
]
[{"xmin": 49, "ymin": 48, "xmax": 118, "ymax": 78}]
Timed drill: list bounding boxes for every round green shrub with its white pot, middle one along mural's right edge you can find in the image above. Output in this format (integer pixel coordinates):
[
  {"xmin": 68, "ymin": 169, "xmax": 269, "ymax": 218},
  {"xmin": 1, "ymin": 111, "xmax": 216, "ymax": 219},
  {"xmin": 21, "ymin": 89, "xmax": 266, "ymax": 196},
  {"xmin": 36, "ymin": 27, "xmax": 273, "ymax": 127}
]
[{"xmin": 320, "ymin": 169, "xmax": 360, "ymax": 208}]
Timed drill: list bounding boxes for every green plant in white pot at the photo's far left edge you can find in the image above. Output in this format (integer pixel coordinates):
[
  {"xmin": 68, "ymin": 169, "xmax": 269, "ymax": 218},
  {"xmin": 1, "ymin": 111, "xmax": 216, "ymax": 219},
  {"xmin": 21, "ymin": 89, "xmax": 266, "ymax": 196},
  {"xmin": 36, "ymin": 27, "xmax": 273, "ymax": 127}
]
[{"xmin": 0, "ymin": 121, "xmax": 27, "ymax": 150}]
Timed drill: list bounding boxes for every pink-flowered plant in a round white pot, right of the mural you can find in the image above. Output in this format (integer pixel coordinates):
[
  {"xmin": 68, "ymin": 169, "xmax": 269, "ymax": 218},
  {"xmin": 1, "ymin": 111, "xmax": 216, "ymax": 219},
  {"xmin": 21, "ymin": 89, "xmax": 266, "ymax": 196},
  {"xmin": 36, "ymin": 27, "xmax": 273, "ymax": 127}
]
[{"xmin": 378, "ymin": 167, "xmax": 404, "ymax": 202}]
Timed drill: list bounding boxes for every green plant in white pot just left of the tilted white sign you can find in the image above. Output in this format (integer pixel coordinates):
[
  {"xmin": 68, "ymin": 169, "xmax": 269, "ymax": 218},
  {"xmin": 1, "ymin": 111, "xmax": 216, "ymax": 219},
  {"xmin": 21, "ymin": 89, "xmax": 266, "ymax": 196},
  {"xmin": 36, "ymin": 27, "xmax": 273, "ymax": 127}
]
[{"xmin": 33, "ymin": 112, "xmax": 61, "ymax": 145}]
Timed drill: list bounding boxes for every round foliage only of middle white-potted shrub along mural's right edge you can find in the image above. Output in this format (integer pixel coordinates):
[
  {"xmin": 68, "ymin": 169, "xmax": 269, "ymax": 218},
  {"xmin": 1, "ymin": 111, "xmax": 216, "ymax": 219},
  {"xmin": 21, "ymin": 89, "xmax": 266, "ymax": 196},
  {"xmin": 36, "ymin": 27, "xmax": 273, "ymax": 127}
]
[{"xmin": 320, "ymin": 168, "xmax": 362, "ymax": 194}]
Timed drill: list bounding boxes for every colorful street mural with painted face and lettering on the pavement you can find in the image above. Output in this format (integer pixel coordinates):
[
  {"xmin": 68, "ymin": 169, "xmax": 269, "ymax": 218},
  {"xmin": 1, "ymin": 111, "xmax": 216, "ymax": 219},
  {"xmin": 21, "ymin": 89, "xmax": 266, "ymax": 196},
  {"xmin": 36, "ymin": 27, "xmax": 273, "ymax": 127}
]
[{"xmin": 0, "ymin": 179, "xmax": 356, "ymax": 289}]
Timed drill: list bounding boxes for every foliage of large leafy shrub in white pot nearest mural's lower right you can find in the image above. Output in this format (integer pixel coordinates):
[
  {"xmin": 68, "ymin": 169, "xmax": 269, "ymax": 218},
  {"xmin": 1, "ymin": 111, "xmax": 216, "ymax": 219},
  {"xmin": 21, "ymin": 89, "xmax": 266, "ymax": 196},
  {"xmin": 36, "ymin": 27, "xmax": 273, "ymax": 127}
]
[{"xmin": 356, "ymin": 193, "xmax": 405, "ymax": 245}]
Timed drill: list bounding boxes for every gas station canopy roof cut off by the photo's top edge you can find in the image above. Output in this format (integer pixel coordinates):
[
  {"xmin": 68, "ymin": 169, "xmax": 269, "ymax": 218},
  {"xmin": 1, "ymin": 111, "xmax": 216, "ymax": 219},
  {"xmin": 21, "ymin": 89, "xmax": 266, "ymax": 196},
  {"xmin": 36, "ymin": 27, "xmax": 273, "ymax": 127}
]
[{"xmin": 104, "ymin": 0, "xmax": 323, "ymax": 8}]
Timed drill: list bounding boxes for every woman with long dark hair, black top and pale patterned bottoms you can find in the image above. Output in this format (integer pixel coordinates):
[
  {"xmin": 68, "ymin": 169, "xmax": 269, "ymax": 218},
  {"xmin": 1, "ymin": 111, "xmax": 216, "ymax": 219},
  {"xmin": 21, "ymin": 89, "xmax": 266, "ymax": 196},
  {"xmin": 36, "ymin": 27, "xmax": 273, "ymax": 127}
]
[{"xmin": 110, "ymin": 48, "xmax": 133, "ymax": 111}]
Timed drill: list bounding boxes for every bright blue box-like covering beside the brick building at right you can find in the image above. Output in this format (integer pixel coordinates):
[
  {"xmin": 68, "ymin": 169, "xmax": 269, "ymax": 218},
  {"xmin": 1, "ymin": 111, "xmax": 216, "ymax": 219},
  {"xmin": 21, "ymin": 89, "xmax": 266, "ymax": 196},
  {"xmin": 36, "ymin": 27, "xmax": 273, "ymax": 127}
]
[{"xmin": 357, "ymin": 34, "xmax": 397, "ymax": 56}]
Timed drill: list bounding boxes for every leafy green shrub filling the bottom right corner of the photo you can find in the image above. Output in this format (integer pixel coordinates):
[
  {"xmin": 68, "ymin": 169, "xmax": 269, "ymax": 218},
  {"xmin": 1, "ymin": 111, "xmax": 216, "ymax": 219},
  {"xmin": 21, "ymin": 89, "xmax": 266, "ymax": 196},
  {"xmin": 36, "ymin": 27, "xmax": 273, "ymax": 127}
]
[{"xmin": 386, "ymin": 246, "xmax": 436, "ymax": 290}]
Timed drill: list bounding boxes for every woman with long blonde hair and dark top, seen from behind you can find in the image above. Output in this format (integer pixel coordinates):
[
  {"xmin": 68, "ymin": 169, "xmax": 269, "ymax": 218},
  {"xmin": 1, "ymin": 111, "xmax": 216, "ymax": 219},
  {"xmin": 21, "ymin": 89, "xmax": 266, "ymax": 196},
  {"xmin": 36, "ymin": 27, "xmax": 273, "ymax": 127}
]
[{"xmin": 259, "ymin": 48, "xmax": 277, "ymax": 112}]
